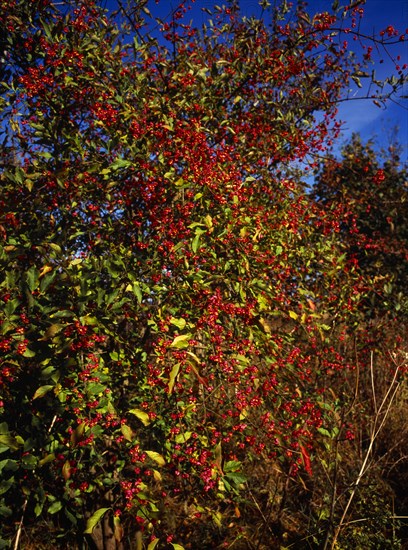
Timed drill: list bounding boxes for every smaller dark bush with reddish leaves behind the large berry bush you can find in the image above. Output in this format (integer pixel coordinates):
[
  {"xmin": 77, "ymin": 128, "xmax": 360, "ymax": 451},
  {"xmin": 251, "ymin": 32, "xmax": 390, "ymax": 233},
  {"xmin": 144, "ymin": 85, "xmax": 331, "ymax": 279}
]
[{"xmin": 314, "ymin": 135, "xmax": 408, "ymax": 317}]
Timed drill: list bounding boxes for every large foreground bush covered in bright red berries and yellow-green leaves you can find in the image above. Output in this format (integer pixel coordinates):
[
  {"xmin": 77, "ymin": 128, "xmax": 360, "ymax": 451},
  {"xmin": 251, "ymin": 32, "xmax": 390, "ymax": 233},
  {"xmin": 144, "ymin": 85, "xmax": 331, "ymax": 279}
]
[{"xmin": 0, "ymin": 0, "xmax": 402, "ymax": 550}]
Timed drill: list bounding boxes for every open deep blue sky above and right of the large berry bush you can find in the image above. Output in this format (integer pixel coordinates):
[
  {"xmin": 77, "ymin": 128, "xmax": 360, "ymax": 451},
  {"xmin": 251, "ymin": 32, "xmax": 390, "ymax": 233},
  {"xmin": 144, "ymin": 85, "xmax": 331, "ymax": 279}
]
[{"xmin": 102, "ymin": 0, "xmax": 408, "ymax": 159}]
